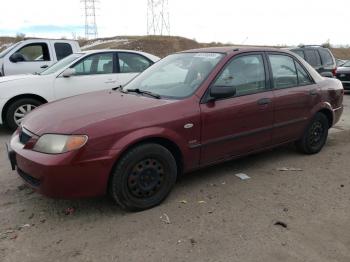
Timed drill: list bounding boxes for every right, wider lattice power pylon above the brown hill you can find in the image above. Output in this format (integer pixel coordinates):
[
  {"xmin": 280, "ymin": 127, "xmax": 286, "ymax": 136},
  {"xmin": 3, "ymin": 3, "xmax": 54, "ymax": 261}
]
[{"xmin": 147, "ymin": 0, "xmax": 170, "ymax": 35}]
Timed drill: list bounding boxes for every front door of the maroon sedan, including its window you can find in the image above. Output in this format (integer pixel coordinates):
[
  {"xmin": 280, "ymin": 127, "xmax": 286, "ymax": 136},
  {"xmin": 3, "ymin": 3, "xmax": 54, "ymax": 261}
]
[{"xmin": 200, "ymin": 53, "xmax": 273, "ymax": 165}]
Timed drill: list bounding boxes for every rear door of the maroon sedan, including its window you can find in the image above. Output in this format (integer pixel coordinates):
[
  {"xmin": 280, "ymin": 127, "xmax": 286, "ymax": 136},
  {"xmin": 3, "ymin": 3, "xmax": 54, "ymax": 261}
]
[{"xmin": 267, "ymin": 53, "xmax": 320, "ymax": 144}]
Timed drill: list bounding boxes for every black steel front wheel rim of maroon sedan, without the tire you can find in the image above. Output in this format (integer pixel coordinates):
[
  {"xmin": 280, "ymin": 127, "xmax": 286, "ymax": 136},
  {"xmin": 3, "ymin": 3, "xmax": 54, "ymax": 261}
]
[{"xmin": 128, "ymin": 159, "xmax": 164, "ymax": 198}]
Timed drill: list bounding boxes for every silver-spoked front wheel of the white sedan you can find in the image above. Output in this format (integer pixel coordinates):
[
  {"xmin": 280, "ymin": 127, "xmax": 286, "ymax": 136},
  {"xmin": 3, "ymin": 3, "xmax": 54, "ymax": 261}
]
[{"xmin": 5, "ymin": 98, "xmax": 42, "ymax": 131}]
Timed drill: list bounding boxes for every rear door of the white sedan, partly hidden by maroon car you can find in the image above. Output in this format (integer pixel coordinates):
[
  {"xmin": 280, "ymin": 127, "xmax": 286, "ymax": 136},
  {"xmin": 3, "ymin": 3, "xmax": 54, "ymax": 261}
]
[{"xmin": 117, "ymin": 52, "xmax": 153, "ymax": 85}]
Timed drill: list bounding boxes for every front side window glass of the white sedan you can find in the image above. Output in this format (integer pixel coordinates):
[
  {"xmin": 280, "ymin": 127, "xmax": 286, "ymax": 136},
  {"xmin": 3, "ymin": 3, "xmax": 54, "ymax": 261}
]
[{"xmin": 73, "ymin": 53, "xmax": 113, "ymax": 75}]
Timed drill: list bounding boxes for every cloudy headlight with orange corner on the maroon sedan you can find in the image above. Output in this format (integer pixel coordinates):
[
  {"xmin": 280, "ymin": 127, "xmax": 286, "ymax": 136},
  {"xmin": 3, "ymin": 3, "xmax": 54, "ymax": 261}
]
[{"xmin": 33, "ymin": 134, "xmax": 88, "ymax": 154}]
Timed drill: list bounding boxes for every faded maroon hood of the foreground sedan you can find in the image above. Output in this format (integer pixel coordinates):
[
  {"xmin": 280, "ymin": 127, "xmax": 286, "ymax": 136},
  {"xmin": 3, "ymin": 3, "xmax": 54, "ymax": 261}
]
[{"xmin": 22, "ymin": 90, "xmax": 174, "ymax": 135}]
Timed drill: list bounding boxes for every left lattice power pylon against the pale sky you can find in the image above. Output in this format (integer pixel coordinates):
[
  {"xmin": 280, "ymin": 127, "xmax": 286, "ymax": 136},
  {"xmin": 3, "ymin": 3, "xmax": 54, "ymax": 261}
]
[{"xmin": 81, "ymin": 0, "xmax": 99, "ymax": 39}]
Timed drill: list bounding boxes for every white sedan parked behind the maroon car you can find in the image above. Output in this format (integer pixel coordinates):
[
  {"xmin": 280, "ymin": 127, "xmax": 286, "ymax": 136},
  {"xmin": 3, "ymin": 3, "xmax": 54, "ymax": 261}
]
[{"xmin": 0, "ymin": 49, "xmax": 159, "ymax": 130}]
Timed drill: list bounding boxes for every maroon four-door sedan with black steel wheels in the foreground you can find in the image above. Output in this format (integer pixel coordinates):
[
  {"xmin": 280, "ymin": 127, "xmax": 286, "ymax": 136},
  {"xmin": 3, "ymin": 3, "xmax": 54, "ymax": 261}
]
[{"xmin": 8, "ymin": 47, "xmax": 344, "ymax": 210}]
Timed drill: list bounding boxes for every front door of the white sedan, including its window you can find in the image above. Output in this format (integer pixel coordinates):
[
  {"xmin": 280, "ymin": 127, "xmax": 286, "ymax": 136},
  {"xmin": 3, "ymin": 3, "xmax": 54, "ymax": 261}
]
[{"xmin": 54, "ymin": 52, "xmax": 117, "ymax": 99}]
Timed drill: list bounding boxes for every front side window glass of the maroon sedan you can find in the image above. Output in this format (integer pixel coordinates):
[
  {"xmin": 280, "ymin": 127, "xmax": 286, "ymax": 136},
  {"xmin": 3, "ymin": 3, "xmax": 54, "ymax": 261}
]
[{"xmin": 214, "ymin": 55, "xmax": 265, "ymax": 96}]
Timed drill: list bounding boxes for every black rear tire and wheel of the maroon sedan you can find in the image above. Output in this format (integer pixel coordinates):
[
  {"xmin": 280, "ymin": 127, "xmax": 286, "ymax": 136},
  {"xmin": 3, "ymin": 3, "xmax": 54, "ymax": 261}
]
[{"xmin": 296, "ymin": 113, "xmax": 329, "ymax": 154}]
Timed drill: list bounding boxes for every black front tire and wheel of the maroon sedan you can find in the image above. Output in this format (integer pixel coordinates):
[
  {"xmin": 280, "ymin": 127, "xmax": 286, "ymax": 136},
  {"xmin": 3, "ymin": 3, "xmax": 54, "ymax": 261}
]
[{"xmin": 109, "ymin": 144, "xmax": 177, "ymax": 211}]
